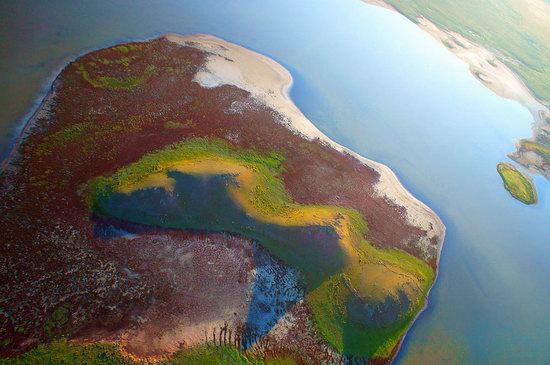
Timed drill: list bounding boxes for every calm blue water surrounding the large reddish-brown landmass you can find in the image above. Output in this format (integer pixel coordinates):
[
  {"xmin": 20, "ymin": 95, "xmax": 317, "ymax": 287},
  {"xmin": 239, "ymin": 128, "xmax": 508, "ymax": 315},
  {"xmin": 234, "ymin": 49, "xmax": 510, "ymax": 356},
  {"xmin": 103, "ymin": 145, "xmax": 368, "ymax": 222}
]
[{"xmin": 0, "ymin": 0, "xmax": 550, "ymax": 364}]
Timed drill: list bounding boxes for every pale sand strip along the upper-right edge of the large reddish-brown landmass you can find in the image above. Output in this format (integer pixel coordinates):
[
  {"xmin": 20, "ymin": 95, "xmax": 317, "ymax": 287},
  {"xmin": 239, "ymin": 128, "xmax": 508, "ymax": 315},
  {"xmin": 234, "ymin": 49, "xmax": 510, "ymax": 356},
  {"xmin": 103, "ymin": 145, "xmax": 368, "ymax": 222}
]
[{"xmin": 165, "ymin": 34, "xmax": 445, "ymax": 257}]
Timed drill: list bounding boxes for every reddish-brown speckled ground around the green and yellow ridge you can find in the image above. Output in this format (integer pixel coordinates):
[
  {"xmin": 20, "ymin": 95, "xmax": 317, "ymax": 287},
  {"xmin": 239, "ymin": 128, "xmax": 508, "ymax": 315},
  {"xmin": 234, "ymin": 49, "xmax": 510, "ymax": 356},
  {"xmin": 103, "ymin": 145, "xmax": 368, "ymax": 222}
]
[{"xmin": 0, "ymin": 38, "xmax": 442, "ymax": 363}]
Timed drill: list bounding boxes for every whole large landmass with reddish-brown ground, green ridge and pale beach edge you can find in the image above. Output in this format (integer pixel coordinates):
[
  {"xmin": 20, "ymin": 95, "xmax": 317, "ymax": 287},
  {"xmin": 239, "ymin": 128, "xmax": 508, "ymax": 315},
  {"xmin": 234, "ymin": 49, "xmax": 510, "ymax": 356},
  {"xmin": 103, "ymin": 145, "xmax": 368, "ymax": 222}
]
[{"xmin": 0, "ymin": 34, "xmax": 445, "ymax": 364}]
